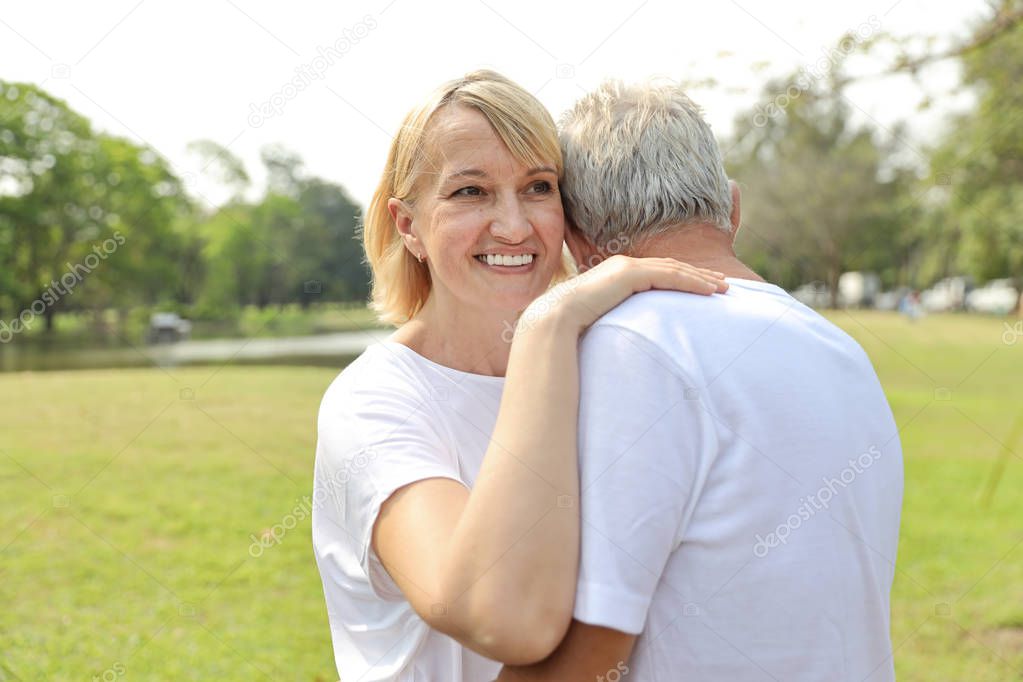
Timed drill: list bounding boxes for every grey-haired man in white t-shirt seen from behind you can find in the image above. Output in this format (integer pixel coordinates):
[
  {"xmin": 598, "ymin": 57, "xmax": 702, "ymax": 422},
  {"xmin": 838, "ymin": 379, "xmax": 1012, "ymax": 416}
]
[{"xmin": 499, "ymin": 83, "xmax": 902, "ymax": 682}]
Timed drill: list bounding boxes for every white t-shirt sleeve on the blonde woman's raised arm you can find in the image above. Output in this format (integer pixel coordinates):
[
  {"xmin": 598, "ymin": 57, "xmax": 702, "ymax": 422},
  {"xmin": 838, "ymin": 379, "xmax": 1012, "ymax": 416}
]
[{"xmin": 317, "ymin": 378, "xmax": 464, "ymax": 599}]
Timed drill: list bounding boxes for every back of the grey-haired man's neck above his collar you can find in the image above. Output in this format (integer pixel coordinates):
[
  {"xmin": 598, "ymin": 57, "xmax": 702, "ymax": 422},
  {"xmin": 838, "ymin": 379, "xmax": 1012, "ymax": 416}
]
[{"xmin": 629, "ymin": 225, "xmax": 764, "ymax": 282}]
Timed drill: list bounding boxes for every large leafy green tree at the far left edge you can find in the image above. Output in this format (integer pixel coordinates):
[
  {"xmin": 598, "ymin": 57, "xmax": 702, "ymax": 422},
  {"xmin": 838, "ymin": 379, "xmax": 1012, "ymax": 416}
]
[{"xmin": 0, "ymin": 81, "xmax": 189, "ymax": 330}]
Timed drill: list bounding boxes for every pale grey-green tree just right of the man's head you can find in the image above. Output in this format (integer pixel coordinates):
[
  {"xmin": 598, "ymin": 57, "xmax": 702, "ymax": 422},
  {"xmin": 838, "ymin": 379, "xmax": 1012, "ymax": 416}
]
[{"xmin": 727, "ymin": 71, "xmax": 915, "ymax": 304}]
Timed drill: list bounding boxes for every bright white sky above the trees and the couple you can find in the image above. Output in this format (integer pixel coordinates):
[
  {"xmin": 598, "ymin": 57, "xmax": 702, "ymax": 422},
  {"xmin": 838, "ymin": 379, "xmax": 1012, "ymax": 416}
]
[{"xmin": 0, "ymin": 0, "xmax": 985, "ymax": 209}]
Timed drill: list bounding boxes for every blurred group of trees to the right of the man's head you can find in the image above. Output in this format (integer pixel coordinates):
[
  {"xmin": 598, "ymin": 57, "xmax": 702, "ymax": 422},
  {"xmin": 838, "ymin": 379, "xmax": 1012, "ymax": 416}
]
[{"xmin": 725, "ymin": 0, "xmax": 1023, "ymax": 308}]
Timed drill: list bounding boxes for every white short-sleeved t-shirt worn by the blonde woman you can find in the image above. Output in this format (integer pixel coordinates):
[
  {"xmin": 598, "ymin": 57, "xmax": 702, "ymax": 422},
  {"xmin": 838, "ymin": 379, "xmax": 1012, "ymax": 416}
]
[{"xmin": 312, "ymin": 342, "xmax": 504, "ymax": 682}]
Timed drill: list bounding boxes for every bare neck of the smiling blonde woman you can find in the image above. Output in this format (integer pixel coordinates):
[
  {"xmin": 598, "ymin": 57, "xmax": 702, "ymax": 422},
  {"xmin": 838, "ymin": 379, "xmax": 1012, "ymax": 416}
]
[{"xmin": 392, "ymin": 295, "xmax": 519, "ymax": 376}]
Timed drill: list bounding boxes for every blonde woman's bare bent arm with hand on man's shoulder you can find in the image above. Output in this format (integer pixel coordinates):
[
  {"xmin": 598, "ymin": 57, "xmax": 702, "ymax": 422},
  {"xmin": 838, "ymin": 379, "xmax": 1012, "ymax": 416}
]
[{"xmin": 373, "ymin": 256, "xmax": 727, "ymax": 665}]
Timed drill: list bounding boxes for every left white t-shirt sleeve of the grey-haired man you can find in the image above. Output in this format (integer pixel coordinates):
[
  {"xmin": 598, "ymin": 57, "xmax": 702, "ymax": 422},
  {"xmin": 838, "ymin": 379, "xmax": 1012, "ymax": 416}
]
[{"xmin": 574, "ymin": 325, "xmax": 716, "ymax": 634}]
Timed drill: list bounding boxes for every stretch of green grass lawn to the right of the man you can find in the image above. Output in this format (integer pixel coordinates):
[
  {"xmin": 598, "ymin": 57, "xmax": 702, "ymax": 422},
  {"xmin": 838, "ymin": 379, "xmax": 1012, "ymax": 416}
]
[{"xmin": 831, "ymin": 311, "xmax": 1023, "ymax": 681}]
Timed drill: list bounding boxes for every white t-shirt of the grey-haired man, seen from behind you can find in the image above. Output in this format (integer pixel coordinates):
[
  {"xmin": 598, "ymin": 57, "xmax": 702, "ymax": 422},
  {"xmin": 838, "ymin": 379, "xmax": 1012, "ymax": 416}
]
[{"xmin": 575, "ymin": 278, "xmax": 902, "ymax": 682}]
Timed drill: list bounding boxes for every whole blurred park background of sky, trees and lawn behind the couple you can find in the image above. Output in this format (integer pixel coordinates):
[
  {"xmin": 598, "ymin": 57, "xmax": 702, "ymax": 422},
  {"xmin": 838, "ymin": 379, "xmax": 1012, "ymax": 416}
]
[{"xmin": 0, "ymin": 0, "xmax": 1023, "ymax": 680}]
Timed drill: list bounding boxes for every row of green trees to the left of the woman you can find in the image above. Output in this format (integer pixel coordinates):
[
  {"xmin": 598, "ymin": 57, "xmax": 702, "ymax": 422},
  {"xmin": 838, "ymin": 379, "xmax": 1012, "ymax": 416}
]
[{"xmin": 0, "ymin": 80, "xmax": 369, "ymax": 335}]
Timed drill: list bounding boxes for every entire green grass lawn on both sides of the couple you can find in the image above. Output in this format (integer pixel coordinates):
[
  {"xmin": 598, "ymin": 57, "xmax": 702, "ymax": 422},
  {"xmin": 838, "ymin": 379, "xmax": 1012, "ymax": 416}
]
[{"xmin": 0, "ymin": 312, "xmax": 1023, "ymax": 681}]
